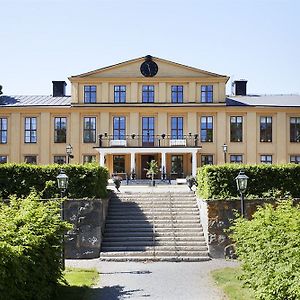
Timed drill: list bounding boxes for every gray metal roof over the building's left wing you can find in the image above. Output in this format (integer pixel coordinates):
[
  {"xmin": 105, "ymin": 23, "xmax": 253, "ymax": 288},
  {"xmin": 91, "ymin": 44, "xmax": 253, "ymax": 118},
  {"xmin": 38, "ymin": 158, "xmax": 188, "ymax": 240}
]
[{"xmin": 0, "ymin": 95, "xmax": 71, "ymax": 107}]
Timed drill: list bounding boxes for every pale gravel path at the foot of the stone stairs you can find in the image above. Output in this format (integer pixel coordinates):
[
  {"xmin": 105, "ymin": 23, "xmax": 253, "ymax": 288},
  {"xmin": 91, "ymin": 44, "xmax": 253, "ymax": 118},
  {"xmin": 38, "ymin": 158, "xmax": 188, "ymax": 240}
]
[{"xmin": 66, "ymin": 259, "xmax": 238, "ymax": 300}]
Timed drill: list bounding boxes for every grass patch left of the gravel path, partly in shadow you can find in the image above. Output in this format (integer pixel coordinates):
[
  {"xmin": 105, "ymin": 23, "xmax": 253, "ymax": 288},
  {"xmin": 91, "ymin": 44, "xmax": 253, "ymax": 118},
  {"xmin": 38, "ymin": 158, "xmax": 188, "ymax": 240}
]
[{"xmin": 53, "ymin": 268, "xmax": 99, "ymax": 300}]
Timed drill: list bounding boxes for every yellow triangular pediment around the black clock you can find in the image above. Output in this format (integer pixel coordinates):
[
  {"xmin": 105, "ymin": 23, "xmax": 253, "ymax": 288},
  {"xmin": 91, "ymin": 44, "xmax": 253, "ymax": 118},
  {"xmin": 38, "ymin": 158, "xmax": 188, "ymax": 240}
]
[{"xmin": 71, "ymin": 57, "xmax": 227, "ymax": 79}]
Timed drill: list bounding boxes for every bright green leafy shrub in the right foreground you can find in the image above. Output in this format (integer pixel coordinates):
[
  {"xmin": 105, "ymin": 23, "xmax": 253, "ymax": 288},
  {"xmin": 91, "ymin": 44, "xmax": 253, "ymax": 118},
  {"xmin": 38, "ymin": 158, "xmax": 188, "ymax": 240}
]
[{"xmin": 231, "ymin": 200, "xmax": 300, "ymax": 300}]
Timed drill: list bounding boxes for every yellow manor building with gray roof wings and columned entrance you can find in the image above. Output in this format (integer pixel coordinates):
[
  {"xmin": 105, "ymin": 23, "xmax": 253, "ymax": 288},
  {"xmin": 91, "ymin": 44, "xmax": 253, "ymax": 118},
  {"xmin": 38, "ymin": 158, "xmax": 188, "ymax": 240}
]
[{"xmin": 0, "ymin": 55, "xmax": 300, "ymax": 179}]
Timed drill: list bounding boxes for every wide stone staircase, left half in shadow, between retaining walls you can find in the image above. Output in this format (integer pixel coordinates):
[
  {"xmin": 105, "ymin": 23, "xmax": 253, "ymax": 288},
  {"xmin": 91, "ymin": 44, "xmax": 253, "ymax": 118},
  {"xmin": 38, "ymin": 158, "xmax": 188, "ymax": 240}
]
[{"xmin": 100, "ymin": 192, "xmax": 209, "ymax": 261}]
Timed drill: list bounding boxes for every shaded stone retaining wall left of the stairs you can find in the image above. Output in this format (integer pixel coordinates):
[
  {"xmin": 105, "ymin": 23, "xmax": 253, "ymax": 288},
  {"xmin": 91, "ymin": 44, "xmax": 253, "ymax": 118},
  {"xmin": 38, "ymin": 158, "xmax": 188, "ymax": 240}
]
[{"xmin": 63, "ymin": 199, "xmax": 109, "ymax": 259}]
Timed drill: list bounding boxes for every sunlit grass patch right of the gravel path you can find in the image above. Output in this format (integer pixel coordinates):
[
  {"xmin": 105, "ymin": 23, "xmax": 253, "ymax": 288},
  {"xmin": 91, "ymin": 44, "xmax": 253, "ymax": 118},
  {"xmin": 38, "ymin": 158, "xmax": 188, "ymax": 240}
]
[{"xmin": 212, "ymin": 268, "xmax": 255, "ymax": 300}]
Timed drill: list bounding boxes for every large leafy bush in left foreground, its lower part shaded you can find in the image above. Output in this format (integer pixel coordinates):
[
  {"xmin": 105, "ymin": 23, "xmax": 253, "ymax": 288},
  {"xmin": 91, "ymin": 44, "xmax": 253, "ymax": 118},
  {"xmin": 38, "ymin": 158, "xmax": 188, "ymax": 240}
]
[{"xmin": 0, "ymin": 194, "xmax": 70, "ymax": 300}]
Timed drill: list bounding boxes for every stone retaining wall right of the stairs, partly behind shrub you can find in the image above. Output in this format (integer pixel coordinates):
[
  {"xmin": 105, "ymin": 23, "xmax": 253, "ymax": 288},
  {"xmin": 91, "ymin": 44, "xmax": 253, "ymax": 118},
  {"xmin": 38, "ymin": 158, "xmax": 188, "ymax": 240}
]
[{"xmin": 198, "ymin": 199, "xmax": 300, "ymax": 258}]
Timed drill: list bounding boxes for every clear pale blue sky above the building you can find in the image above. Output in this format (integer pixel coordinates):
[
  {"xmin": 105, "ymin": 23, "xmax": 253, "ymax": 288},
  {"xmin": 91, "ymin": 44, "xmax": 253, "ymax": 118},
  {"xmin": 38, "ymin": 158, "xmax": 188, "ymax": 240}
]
[{"xmin": 0, "ymin": 0, "xmax": 300, "ymax": 95}]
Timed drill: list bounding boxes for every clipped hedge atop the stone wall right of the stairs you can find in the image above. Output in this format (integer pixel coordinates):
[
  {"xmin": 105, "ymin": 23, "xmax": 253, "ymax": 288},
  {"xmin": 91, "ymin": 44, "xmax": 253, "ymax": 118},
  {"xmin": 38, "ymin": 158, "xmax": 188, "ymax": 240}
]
[{"xmin": 197, "ymin": 164, "xmax": 300, "ymax": 199}]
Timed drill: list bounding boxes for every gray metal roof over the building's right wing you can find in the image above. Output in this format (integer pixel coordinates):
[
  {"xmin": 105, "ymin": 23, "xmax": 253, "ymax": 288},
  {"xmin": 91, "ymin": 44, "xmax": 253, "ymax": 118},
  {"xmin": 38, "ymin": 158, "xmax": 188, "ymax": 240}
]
[{"xmin": 226, "ymin": 95, "xmax": 300, "ymax": 107}]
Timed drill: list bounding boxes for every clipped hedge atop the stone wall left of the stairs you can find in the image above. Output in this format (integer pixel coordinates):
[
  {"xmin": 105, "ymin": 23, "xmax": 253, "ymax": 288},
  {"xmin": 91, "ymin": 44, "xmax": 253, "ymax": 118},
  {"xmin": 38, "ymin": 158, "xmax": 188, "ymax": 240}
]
[{"xmin": 0, "ymin": 164, "xmax": 108, "ymax": 199}]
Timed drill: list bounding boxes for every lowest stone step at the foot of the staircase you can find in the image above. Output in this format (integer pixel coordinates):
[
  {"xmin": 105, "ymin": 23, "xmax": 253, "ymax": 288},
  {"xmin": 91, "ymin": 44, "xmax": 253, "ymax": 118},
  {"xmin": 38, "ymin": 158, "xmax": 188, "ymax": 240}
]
[{"xmin": 100, "ymin": 255, "xmax": 210, "ymax": 262}]
